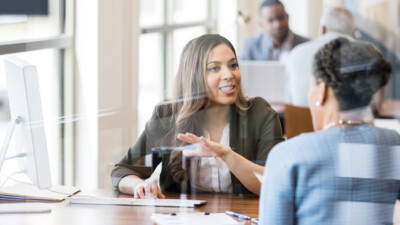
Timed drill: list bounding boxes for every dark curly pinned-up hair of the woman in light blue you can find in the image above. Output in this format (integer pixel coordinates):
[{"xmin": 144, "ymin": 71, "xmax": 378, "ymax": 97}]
[{"xmin": 313, "ymin": 38, "xmax": 392, "ymax": 111}]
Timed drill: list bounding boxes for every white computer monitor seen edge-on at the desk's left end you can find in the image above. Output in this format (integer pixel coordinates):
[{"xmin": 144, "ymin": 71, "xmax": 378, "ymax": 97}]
[{"xmin": 0, "ymin": 56, "xmax": 52, "ymax": 189}]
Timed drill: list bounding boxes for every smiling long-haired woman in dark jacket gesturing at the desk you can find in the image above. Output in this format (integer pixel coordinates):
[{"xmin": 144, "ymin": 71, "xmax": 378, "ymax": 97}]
[{"xmin": 111, "ymin": 34, "xmax": 284, "ymax": 198}]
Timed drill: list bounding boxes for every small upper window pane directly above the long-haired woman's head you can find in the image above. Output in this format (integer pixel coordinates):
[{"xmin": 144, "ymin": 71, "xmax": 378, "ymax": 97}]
[{"xmin": 171, "ymin": 0, "xmax": 208, "ymax": 24}]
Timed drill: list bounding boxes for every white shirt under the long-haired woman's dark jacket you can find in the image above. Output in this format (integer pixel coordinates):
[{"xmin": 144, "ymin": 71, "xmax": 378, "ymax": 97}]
[{"xmin": 146, "ymin": 124, "xmax": 232, "ymax": 193}]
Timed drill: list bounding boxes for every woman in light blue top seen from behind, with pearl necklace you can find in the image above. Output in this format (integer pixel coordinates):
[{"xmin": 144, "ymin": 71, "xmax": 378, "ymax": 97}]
[{"xmin": 259, "ymin": 38, "xmax": 400, "ymax": 225}]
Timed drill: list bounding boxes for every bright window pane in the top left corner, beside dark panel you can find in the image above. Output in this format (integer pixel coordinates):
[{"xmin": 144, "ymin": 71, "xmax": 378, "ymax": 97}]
[{"xmin": 0, "ymin": 0, "xmax": 60, "ymax": 42}]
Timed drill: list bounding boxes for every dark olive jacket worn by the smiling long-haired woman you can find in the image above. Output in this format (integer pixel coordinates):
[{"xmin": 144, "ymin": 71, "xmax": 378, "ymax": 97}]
[{"xmin": 111, "ymin": 97, "xmax": 284, "ymax": 193}]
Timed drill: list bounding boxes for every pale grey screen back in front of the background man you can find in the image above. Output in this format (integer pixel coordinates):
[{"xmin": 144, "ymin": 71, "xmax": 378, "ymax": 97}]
[{"xmin": 239, "ymin": 61, "xmax": 287, "ymax": 103}]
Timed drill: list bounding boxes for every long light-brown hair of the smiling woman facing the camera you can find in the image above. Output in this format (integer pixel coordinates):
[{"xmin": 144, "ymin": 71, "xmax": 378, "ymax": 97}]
[{"xmin": 166, "ymin": 34, "xmax": 250, "ymax": 189}]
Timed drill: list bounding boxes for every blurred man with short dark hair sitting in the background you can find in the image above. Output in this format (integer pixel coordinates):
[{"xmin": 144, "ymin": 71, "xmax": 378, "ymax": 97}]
[{"xmin": 239, "ymin": 0, "xmax": 308, "ymax": 62}]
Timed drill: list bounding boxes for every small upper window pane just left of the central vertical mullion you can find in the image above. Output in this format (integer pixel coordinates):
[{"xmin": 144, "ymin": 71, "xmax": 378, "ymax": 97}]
[{"xmin": 140, "ymin": 0, "xmax": 164, "ymax": 27}]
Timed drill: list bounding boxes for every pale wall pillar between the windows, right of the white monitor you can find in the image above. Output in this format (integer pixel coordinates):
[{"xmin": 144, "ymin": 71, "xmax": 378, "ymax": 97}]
[{"xmin": 75, "ymin": 0, "xmax": 140, "ymax": 188}]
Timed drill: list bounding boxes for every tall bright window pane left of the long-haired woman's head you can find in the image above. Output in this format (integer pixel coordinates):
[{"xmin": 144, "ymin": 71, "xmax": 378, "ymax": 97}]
[{"xmin": 138, "ymin": 33, "xmax": 164, "ymax": 131}]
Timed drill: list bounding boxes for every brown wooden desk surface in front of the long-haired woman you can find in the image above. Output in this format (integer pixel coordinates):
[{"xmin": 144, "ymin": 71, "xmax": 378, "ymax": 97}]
[{"xmin": 0, "ymin": 190, "xmax": 259, "ymax": 225}]
